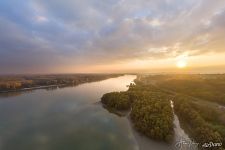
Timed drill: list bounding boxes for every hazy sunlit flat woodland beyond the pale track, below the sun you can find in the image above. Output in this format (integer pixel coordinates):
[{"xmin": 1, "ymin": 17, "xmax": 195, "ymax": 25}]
[{"xmin": 147, "ymin": 74, "xmax": 225, "ymax": 105}]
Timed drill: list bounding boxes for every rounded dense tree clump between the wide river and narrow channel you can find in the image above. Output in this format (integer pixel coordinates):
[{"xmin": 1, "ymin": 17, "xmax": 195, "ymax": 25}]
[{"xmin": 101, "ymin": 82, "xmax": 173, "ymax": 142}]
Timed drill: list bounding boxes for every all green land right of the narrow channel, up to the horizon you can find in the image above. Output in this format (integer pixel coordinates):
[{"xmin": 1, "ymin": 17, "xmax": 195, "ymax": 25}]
[{"xmin": 138, "ymin": 74, "xmax": 225, "ymax": 149}]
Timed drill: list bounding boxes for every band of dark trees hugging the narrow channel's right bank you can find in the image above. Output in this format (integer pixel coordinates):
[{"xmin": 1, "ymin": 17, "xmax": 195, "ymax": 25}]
[{"xmin": 174, "ymin": 95, "xmax": 225, "ymax": 149}]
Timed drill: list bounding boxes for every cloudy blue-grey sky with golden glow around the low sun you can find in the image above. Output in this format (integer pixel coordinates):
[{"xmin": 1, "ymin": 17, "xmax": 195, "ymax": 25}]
[{"xmin": 0, "ymin": 0, "xmax": 225, "ymax": 74}]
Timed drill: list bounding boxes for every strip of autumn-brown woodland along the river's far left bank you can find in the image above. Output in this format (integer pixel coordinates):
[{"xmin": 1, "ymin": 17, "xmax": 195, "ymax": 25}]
[{"xmin": 0, "ymin": 74, "xmax": 123, "ymax": 93}]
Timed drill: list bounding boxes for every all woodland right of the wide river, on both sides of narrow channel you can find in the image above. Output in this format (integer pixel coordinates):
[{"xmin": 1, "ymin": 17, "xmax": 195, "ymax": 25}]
[{"xmin": 101, "ymin": 74, "xmax": 225, "ymax": 149}]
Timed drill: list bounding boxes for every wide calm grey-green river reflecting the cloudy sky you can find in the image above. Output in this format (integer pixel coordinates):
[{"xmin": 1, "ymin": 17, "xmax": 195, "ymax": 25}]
[{"xmin": 0, "ymin": 75, "xmax": 192, "ymax": 150}]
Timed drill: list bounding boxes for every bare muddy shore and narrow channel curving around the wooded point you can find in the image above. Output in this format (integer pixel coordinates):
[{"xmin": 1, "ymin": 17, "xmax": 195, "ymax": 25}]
[{"xmin": 102, "ymin": 99, "xmax": 192, "ymax": 150}]
